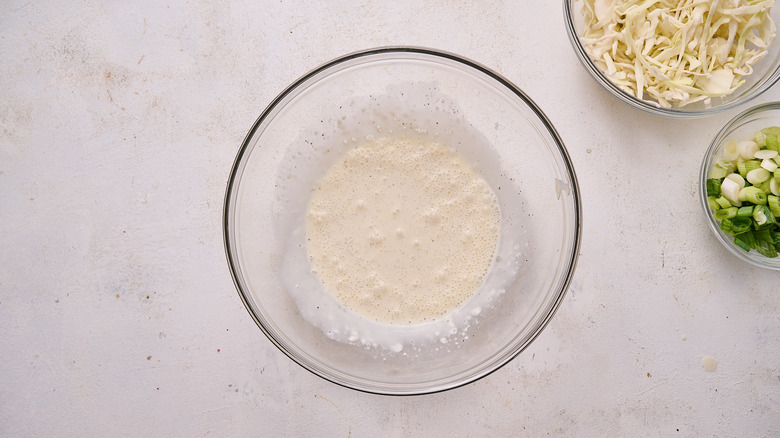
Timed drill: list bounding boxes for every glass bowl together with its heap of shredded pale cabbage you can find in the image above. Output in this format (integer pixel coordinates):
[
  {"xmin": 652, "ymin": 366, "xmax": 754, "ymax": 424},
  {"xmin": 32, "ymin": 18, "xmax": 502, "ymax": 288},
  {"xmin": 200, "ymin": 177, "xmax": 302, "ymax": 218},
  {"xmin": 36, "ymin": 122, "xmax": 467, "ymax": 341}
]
[{"xmin": 563, "ymin": 0, "xmax": 780, "ymax": 118}]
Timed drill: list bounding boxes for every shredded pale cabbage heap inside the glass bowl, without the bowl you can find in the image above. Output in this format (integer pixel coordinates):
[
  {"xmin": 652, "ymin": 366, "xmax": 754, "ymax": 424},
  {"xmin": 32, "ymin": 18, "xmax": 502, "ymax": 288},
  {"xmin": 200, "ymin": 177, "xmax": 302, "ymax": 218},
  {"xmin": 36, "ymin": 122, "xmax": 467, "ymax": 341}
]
[{"xmin": 582, "ymin": 0, "xmax": 776, "ymax": 108}]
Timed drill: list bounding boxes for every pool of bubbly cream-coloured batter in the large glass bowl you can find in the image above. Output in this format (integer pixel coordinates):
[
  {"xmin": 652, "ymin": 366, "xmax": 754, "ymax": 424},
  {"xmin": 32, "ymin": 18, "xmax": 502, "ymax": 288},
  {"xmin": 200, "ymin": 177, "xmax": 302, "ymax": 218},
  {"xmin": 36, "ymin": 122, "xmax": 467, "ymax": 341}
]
[{"xmin": 305, "ymin": 137, "xmax": 501, "ymax": 324}]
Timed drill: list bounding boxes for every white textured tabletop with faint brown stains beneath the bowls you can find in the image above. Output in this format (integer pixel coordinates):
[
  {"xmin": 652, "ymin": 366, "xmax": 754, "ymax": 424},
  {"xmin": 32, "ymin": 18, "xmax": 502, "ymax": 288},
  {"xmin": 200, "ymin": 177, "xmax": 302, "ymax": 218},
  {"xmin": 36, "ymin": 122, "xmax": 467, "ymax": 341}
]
[{"xmin": 0, "ymin": 0, "xmax": 780, "ymax": 437}]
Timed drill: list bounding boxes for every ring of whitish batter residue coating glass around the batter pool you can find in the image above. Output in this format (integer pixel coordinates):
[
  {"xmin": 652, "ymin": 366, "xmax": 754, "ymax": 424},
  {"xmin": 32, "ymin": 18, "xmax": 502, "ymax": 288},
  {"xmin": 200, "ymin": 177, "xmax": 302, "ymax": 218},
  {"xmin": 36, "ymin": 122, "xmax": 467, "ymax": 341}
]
[{"xmin": 273, "ymin": 82, "xmax": 529, "ymax": 354}]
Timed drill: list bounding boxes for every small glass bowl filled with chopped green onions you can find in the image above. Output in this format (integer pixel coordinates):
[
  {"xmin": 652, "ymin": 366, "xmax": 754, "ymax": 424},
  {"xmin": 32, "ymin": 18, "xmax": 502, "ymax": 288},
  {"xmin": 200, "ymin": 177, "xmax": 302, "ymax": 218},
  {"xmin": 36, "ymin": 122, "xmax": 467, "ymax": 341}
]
[{"xmin": 699, "ymin": 102, "xmax": 780, "ymax": 270}]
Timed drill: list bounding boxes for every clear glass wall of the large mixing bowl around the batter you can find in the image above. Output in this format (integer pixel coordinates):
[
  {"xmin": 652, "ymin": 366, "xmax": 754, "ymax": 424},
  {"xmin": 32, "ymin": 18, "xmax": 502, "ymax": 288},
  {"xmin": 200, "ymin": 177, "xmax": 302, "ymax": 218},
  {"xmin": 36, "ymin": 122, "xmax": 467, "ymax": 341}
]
[{"xmin": 223, "ymin": 47, "xmax": 582, "ymax": 395}]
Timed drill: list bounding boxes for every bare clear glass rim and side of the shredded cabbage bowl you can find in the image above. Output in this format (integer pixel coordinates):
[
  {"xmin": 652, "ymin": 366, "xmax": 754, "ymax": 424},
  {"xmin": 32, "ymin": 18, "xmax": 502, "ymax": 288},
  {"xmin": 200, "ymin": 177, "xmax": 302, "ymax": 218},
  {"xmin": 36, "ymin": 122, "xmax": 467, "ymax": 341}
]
[{"xmin": 563, "ymin": 0, "xmax": 780, "ymax": 119}]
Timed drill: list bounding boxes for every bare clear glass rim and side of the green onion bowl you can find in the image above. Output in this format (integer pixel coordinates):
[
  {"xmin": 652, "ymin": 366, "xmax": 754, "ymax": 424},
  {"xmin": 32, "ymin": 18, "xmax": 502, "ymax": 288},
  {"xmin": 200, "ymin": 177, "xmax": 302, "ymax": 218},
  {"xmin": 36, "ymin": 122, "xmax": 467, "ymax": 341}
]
[{"xmin": 699, "ymin": 102, "xmax": 780, "ymax": 270}]
